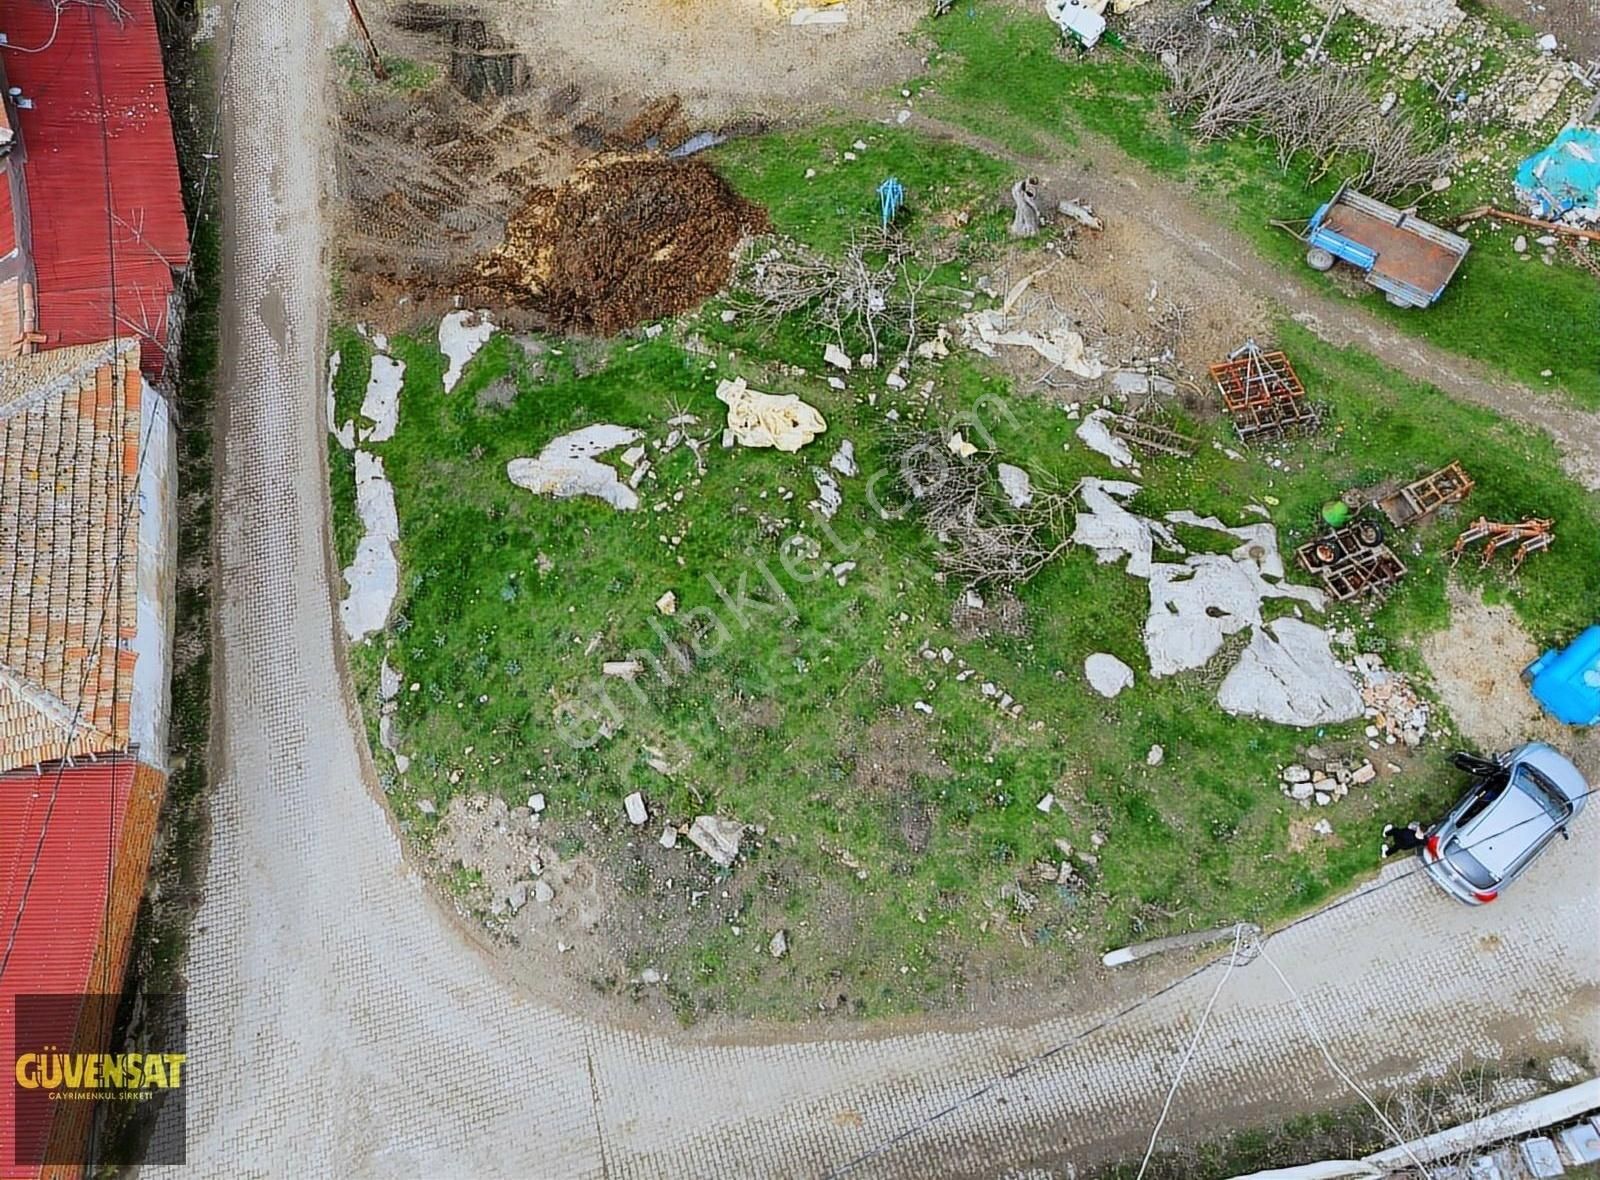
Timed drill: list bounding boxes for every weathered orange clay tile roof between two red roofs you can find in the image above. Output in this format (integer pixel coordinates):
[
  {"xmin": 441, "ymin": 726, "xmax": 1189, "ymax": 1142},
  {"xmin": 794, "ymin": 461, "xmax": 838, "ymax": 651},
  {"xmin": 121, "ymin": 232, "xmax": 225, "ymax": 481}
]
[{"xmin": 0, "ymin": 341, "xmax": 141, "ymax": 772}]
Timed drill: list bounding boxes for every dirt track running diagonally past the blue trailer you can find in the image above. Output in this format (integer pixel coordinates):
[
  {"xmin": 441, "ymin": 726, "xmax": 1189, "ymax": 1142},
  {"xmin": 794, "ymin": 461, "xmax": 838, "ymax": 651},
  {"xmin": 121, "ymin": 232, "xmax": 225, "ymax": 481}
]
[{"xmin": 889, "ymin": 106, "xmax": 1600, "ymax": 491}]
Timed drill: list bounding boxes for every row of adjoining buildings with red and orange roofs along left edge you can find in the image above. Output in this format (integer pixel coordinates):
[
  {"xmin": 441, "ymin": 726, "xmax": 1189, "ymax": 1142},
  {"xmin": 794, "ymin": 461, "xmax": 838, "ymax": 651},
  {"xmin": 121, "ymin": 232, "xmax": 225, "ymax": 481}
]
[{"xmin": 0, "ymin": 0, "xmax": 189, "ymax": 1180}]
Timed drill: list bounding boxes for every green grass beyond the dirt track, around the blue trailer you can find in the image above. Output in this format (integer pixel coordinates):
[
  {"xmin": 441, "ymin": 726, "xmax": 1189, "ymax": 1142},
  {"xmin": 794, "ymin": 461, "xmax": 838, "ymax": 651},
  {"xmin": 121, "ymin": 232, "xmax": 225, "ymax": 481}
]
[{"xmin": 917, "ymin": 0, "xmax": 1600, "ymax": 408}]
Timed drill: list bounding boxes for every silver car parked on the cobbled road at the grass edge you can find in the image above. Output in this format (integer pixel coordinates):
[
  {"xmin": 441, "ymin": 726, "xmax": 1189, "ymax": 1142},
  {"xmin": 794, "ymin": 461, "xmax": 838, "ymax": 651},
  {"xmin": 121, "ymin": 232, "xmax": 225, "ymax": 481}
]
[{"xmin": 1422, "ymin": 742, "xmax": 1589, "ymax": 905}]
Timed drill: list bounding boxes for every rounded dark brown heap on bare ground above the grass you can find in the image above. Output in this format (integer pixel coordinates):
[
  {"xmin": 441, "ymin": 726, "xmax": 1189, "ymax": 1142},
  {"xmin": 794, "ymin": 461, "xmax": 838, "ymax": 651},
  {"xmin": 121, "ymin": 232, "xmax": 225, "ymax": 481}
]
[{"xmin": 477, "ymin": 155, "xmax": 768, "ymax": 336}]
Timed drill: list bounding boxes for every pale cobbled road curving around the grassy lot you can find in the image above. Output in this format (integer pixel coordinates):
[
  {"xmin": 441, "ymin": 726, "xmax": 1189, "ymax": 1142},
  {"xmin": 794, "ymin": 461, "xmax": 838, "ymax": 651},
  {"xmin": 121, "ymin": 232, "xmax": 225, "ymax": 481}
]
[{"xmin": 150, "ymin": 0, "xmax": 1600, "ymax": 1180}]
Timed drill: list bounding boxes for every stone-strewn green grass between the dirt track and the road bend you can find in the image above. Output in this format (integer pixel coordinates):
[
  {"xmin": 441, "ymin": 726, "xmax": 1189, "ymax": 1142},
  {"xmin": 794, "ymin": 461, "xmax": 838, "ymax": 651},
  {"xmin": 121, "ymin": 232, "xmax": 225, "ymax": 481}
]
[{"xmin": 333, "ymin": 128, "xmax": 1600, "ymax": 1019}]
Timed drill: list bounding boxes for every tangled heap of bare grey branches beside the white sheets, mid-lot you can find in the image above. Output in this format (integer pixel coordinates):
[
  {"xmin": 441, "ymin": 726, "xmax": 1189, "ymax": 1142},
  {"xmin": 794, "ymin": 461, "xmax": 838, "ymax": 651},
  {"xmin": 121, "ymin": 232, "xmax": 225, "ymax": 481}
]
[{"xmin": 888, "ymin": 427, "xmax": 1072, "ymax": 587}]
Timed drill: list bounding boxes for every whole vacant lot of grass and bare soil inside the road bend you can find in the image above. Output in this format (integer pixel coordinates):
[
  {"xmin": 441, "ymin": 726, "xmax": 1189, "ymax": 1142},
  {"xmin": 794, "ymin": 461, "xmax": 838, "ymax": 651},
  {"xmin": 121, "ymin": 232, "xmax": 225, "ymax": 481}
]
[{"xmin": 330, "ymin": 0, "xmax": 1600, "ymax": 1020}]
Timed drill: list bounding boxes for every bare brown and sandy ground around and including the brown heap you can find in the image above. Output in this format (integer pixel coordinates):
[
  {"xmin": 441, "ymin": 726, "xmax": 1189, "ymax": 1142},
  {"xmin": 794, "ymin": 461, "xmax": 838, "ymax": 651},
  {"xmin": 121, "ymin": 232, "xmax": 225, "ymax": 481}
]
[{"xmin": 338, "ymin": 0, "xmax": 923, "ymax": 331}]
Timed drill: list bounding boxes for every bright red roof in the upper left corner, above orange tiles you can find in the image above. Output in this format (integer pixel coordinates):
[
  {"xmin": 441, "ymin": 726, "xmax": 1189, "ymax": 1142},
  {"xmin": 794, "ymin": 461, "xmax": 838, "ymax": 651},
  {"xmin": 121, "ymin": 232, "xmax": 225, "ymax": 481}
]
[{"xmin": 0, "ymin": 0, "xmax": 189, "ymax": 376}]
